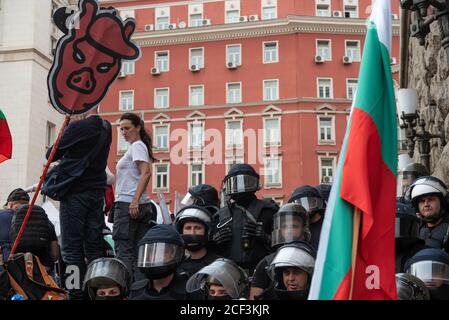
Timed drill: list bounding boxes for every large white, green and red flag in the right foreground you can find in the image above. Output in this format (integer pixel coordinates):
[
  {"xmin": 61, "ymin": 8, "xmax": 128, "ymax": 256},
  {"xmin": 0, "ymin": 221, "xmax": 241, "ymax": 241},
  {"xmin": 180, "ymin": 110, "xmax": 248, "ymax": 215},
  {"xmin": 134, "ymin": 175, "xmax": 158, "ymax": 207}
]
[{"xmin": 309, "ymin": 0, "xmax": 397, "ymax": 300}]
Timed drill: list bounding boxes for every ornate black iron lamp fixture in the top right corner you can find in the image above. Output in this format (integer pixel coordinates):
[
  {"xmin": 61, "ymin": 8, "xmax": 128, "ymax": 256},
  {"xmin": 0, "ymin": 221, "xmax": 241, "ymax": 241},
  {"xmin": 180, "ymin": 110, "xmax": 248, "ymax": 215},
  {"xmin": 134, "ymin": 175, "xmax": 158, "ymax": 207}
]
[{"xmin": 399, "ymin": 0, "xmax": 449, "ymax": 62}]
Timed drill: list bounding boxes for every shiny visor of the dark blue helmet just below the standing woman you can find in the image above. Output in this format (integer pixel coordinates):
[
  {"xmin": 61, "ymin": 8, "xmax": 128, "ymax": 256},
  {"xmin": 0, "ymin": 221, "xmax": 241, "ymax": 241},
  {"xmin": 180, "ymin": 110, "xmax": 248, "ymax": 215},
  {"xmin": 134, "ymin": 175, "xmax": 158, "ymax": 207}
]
[{"xmin": 137, "ymin": 242, "xmax": 184, "ymax": 268}]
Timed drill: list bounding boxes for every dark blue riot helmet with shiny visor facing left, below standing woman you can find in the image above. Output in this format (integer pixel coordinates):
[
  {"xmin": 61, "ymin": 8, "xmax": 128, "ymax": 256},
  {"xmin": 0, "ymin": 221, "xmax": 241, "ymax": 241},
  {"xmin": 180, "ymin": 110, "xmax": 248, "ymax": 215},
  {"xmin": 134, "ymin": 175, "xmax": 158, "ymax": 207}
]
[{"xmin": 137, "ymin": 224, "xmax": 185, "ymax": 280}]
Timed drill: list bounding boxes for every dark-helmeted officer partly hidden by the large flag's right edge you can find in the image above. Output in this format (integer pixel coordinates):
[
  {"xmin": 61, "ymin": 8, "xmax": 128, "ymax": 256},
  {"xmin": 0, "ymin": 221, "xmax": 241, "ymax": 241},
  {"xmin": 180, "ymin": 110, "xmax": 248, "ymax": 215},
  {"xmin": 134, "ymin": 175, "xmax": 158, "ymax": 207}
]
[{"xmin": 395, "ymin": 201, "xmax": 425, "ymax": 273}]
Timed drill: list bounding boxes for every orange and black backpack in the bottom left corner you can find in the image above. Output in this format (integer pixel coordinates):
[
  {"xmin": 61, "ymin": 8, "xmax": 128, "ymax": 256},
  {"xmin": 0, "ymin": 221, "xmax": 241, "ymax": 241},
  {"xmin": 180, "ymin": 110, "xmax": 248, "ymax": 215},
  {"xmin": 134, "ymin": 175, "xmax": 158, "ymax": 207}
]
[{"xmin": 6, "ymin": 252, "xmax": 67, "ymax": 300}]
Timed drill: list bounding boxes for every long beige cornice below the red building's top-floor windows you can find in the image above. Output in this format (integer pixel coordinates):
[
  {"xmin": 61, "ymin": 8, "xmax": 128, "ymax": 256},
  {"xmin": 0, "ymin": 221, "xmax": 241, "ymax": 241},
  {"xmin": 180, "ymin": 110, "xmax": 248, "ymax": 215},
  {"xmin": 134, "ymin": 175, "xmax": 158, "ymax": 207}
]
[{"xmin": 133, "ymin": 16, "xmax": 400, "ymax": 47}]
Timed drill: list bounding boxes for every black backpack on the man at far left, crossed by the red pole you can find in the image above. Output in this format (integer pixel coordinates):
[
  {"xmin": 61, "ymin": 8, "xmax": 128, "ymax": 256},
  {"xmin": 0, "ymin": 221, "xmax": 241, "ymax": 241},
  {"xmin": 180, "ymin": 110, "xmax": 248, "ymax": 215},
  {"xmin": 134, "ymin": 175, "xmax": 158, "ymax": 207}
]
[{"xmin": 9, "ymin": 205, "xmax": 51, "ymax": 254}]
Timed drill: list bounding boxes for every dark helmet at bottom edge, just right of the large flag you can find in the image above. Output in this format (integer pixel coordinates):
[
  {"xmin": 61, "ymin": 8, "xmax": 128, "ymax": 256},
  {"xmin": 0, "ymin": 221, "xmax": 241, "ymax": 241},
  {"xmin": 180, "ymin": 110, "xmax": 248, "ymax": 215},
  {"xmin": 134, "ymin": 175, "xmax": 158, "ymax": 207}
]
[{"xmin": 396, "ymin": 273, "xmax": 430, "ymax": 300}]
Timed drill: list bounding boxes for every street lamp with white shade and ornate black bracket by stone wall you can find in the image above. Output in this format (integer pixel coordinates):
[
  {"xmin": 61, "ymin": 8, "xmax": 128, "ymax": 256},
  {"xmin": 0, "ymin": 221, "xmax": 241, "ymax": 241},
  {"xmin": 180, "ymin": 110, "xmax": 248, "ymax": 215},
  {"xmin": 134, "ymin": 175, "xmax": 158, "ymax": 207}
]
[{"xmin": 398, "ymin": 89, "xmax": 446, "ymax": 172}]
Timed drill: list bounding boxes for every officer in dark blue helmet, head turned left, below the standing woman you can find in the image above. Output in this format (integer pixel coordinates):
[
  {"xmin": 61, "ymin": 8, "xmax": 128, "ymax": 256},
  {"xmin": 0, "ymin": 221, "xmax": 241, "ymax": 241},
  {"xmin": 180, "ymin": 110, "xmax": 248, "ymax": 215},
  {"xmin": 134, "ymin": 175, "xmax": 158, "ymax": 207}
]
[{"xmin": 129, "ymin": 224, "xmax": 188, "ymax": 300}]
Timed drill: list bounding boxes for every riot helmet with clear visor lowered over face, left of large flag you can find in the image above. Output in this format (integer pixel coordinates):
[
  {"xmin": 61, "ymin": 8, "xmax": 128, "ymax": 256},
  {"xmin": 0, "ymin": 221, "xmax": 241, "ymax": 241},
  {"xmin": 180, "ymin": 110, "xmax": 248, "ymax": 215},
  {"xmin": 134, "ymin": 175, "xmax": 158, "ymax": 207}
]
[{"xmin": 271, "ymin": 203, "xmax": 311, "ymax": 248}]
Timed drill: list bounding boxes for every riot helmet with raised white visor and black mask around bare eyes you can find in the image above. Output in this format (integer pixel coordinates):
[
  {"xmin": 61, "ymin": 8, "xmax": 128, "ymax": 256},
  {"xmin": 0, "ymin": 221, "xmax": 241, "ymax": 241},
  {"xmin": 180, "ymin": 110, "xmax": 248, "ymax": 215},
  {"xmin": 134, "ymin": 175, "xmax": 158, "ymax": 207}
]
[{"xmin": 175, "ymin": 205, "xmax": 212, "ymax": 251}]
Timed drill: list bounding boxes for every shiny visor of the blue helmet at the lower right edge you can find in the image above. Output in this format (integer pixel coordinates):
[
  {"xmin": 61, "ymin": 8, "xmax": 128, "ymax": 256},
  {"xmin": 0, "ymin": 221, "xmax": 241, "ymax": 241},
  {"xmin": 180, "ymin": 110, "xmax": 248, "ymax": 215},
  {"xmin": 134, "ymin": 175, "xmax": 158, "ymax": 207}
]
[{"xmin": 407, "ymin": 261, "xmax": 449, "ymax": 288}]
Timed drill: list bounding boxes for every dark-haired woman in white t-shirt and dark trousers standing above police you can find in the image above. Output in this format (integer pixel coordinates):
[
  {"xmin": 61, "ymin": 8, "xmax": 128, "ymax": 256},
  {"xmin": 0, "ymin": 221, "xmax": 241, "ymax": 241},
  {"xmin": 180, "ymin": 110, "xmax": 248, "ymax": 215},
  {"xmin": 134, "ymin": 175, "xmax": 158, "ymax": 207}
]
[{"xmin": 112, "ymin": 113, "xmax": 156, "ymax": 280}]
